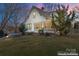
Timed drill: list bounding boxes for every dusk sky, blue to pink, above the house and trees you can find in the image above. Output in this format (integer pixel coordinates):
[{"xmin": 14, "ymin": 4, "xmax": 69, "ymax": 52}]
[{"xmin": 0, "ymin": 3, "xmax": 79, "ymax": 21}]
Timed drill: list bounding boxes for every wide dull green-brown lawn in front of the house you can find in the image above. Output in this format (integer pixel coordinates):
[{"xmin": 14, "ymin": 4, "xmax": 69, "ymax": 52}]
[{"xmin": 0, "ymin": 35, "xmax": 79, "ymax": 56}]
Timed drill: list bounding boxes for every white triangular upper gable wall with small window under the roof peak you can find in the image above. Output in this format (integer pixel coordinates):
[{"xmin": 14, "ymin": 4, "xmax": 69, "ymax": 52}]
[{"xmin": 26, "ymin": 9, "xmax": 46, "ymax": 23}]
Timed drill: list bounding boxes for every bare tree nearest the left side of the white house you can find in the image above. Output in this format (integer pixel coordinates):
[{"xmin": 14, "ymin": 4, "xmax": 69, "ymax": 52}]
[{"xmin": 8, "ymin": 4, "xmax": 27, "ymax": 32}]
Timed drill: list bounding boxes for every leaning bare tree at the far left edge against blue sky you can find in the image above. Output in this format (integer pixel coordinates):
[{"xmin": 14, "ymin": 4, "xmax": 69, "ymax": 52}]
[{"xmin": 0, "ymin": 4, "xmax": 15, "ymax": 35}]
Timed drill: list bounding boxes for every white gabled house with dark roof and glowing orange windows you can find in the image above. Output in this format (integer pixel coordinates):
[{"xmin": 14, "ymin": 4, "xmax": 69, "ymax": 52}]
[{"xmin": 25, "ymin": 6, "xmax": 54, "ymax": 33}]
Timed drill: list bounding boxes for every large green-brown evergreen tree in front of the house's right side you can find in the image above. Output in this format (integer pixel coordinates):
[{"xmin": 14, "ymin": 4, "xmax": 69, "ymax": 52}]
[{"xmin": 52, "ymin": 5, "xmax": 76, "ymax": 35}]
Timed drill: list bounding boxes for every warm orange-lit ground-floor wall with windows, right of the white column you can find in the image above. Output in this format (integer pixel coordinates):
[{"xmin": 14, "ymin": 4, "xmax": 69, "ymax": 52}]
[{"xmin": 34, "ymin": 20, "xmax": 52, "ymax": 31}]
